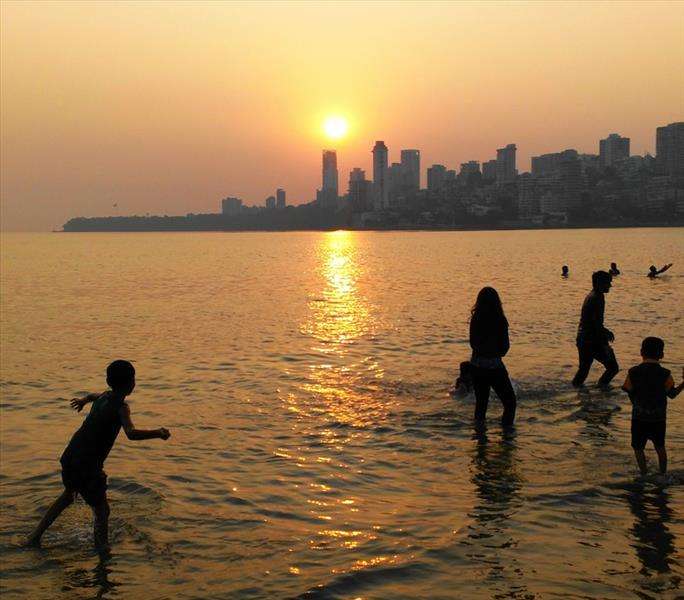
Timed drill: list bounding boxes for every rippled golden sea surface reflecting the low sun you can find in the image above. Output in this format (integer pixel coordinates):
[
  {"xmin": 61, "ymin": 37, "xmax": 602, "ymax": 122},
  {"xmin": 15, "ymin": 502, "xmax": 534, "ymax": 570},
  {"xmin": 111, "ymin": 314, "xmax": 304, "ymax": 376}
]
[{"xmin": 0, "ymin": 229, "xmax": 684, "ymax": 599}]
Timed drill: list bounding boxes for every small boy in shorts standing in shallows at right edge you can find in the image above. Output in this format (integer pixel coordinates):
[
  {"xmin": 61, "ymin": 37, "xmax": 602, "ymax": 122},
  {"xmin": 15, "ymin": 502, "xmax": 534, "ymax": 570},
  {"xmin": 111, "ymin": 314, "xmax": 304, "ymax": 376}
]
[{"xmin": 622, "ymin": 337, "xmax": 684, "ymax": 475}]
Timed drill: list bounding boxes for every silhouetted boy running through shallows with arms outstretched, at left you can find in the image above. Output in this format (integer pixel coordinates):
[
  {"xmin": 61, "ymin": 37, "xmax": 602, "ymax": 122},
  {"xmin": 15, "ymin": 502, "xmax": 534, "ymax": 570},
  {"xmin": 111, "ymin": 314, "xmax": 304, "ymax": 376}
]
[{"xmin": 27, "ymin": 360, "xmax": 171, "ymax": 547}]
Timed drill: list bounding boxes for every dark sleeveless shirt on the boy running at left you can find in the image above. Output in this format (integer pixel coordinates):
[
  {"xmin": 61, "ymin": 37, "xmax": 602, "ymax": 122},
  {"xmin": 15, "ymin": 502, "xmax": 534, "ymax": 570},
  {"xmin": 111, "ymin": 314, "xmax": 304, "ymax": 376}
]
[{"xmin": 60, "ymin": 392, "xmax": 123, "ymax": 469}]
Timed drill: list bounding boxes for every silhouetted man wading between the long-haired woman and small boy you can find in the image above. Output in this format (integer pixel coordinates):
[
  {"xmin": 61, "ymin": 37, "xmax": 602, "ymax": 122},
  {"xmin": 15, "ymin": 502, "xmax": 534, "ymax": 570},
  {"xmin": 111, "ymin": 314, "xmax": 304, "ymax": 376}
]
[{"xmin": 572, "ymin": 271, "xmax": 620, "ymax": 387}]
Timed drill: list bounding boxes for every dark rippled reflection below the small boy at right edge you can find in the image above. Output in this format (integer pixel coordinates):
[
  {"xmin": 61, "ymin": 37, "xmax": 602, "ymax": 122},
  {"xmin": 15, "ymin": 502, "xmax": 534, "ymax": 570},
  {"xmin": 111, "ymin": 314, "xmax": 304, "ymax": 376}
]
[{"xmin": 626, "ymin": 486, "xmax": 675, "ymax": 576}]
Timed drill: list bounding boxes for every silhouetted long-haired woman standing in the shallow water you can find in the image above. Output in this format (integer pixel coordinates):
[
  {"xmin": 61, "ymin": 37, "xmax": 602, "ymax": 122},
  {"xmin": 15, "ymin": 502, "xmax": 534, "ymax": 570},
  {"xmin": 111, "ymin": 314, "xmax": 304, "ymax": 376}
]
[{"xmin": 470, "ymin": 287, "xmax": 516, "ymax": 427}]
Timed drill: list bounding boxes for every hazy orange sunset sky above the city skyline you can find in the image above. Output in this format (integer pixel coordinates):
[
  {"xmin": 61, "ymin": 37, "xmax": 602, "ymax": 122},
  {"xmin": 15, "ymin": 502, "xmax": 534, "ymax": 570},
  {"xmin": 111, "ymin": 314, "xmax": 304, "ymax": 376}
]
[{"xmin": 0, "ymin": 0, "xmax": 684, "ymax": 230}]
